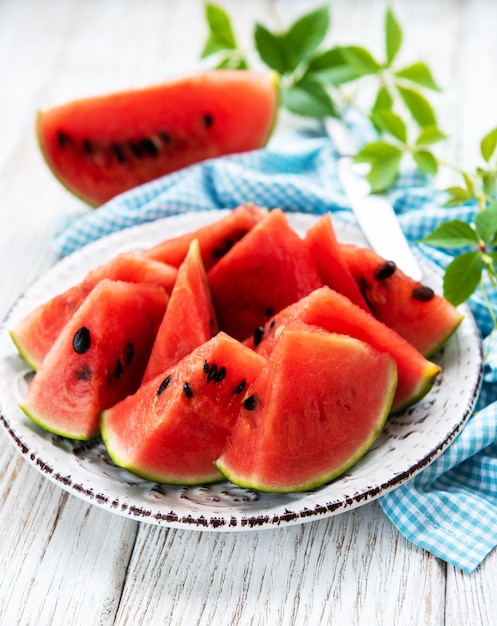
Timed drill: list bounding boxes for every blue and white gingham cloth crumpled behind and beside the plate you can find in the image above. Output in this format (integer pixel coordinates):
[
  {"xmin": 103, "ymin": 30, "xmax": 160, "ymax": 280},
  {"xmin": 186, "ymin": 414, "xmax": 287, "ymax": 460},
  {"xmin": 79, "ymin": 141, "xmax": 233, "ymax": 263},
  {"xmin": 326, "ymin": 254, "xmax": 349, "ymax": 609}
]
[{"xmin": 54, "ymin": 126, "xmax": 497, "ymax": 572}]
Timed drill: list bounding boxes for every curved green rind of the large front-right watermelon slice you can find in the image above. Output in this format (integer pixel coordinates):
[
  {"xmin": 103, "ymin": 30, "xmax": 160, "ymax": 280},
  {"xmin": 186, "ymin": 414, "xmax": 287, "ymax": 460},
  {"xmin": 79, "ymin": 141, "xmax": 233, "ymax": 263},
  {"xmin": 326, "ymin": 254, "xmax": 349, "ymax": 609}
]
[{"xmin": 214, "ymin": 363, "xmax": 397, "ymax": 494}]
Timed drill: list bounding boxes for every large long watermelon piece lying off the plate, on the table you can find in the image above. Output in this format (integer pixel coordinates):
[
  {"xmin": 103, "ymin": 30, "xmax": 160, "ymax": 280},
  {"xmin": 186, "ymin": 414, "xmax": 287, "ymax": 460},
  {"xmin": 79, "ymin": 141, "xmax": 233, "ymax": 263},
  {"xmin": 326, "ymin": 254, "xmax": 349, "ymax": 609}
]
[{"xmin": 37, "ymin": 70, "xmax": 279, "ymax": 205}]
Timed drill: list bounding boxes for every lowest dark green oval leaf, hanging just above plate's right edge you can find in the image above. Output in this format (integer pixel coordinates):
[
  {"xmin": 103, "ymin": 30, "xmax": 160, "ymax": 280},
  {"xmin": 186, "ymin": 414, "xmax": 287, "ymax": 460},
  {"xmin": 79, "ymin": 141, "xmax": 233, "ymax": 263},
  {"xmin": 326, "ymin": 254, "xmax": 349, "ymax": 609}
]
[{"xmin": 443, "ymin": 251, "xmax": 483, "ymax": 306}]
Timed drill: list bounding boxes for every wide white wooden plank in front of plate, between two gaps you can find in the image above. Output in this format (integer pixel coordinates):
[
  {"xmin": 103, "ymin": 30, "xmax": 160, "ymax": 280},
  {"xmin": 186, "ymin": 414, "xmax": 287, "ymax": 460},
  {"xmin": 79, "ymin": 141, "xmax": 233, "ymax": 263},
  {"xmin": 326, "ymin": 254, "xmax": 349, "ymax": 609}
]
[{"xmin": 116, "ymin": 503, "xmax": 445, "ymax": 626}]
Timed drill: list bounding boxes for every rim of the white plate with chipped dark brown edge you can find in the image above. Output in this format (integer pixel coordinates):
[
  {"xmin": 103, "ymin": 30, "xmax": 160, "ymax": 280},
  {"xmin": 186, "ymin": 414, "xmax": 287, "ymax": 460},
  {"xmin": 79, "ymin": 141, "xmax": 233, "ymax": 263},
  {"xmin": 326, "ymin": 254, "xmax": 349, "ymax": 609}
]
[{"xmin": 0, "ymin": 209, "xmax": 484, "ymax": 531}]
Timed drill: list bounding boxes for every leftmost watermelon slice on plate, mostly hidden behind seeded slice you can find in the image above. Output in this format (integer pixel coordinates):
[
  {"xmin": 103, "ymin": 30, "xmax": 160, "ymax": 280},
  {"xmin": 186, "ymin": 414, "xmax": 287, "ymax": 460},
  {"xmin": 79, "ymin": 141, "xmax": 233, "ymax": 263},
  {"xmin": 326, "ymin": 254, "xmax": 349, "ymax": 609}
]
[{"xmin": 10, "ymin": 253, "xmax": 178, "ymax": 370}]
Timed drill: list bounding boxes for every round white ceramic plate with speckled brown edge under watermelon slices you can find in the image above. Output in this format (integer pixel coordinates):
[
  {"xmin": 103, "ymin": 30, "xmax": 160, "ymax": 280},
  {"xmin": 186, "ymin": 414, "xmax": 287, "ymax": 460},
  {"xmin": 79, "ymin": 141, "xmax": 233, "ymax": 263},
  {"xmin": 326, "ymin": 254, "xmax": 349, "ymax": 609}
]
[{"xmin": 0, "ymin": 211, "xmax": 482, "ymax": 531}]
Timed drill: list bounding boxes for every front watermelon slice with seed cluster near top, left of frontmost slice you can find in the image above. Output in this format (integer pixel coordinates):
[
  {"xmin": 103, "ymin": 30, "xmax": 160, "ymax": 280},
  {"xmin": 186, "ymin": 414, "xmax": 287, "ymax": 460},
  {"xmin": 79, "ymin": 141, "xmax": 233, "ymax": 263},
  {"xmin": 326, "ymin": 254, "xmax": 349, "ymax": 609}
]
[{"xmin": 101, "ymin": 332, "xmax": 265, "ymax": 484}]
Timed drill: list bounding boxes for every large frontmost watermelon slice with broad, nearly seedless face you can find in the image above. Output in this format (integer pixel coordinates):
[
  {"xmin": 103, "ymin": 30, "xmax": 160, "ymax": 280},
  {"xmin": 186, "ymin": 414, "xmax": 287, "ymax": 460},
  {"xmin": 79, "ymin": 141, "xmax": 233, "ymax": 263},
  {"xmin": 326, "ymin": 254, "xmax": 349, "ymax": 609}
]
[{"xmin": 215, "ymin": 327, "xmax": 397, "ymax": 493}]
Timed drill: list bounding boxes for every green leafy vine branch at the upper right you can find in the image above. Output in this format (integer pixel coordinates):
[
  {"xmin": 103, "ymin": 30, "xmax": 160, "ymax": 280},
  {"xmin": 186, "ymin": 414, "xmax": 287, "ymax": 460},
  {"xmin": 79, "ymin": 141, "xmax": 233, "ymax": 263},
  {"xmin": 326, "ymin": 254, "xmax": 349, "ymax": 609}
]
[{"xmin": 202, "ymin": 3, "xmax": 497, "ymax": 320}]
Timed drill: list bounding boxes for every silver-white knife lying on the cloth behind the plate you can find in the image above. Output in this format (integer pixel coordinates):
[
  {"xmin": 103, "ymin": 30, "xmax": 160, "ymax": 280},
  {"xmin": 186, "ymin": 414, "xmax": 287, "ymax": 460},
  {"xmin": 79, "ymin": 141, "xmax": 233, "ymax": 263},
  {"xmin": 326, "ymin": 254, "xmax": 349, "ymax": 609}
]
[{"xmin": 325, "ymin": 118, "xmax": 423, "ymax": 280}]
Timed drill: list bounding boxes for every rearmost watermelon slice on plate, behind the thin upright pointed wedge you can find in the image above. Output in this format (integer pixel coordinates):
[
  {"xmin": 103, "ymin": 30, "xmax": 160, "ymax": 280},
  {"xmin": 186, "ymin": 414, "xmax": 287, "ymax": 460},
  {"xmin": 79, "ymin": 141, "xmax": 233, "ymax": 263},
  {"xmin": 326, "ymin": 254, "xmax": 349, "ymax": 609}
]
[{"xmin": 143, "ymin": 203, "xmax": 267, "ymax": 272}]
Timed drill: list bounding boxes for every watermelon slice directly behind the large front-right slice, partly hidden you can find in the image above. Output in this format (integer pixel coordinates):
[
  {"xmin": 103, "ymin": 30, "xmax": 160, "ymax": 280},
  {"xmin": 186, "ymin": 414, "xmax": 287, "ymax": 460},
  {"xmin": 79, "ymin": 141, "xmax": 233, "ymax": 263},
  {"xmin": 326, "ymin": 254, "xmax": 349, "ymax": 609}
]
[{"xmin": 250, "ymin": 287, "xmax": 440, "ymax": 412}]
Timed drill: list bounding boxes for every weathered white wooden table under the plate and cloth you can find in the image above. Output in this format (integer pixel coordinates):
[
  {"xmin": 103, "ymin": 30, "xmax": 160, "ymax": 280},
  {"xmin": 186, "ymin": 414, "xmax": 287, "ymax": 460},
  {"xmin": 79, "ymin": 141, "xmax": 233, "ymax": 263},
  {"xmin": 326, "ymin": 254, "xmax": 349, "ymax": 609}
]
[{"xmin": 0, "ymin": 0, "xmax": 497, "ymax": 626}]
